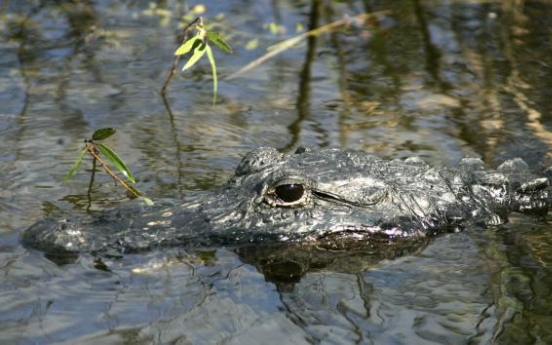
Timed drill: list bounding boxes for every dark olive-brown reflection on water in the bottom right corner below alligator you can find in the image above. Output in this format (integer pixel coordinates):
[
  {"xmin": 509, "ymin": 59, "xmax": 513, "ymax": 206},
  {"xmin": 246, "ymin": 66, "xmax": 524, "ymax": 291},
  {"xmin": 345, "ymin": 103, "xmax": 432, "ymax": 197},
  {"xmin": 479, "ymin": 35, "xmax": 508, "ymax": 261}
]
[{"xmin": 483, "ymin": 224, "xmax": 552, "ymax": 344}]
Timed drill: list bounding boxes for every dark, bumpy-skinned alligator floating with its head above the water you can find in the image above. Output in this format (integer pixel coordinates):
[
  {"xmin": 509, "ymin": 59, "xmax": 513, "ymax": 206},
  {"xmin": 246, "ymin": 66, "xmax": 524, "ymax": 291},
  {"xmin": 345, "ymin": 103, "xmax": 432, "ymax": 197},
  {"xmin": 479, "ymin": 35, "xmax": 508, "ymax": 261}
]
[{"xmin": 23, "ymin": 148, "xmax": 551, "ymax": 253}]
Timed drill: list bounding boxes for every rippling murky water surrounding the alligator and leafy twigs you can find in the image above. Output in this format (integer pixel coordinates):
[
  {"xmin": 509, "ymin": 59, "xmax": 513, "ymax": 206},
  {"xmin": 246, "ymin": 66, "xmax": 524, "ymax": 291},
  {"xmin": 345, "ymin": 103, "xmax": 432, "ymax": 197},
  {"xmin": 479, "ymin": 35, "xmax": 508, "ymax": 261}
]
[{"xmin": 0, "ymin": 0, "xmax": 552, "ymax": 344}]
